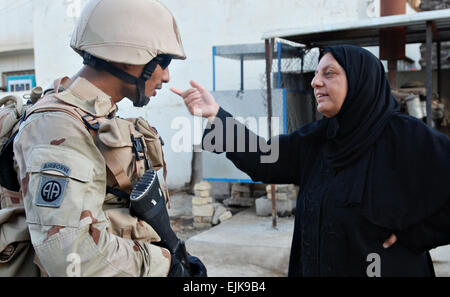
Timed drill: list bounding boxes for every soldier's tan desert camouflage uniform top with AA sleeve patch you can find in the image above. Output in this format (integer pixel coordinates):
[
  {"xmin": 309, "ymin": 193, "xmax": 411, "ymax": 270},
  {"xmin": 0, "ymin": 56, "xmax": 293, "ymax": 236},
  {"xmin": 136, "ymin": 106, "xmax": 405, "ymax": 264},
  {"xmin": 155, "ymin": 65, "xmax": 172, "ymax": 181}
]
[{"xmin": 14, "ymin": 78, "xmax": 170, "ymax": 276}]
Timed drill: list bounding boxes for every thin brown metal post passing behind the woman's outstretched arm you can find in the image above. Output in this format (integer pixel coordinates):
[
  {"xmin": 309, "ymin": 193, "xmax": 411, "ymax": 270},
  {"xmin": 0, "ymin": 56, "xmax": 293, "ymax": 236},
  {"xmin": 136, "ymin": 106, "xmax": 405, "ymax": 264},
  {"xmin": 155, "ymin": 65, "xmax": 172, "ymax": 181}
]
[{"xmin": 266, "ymin": 38, "xmax": 277, "ymax": 229}]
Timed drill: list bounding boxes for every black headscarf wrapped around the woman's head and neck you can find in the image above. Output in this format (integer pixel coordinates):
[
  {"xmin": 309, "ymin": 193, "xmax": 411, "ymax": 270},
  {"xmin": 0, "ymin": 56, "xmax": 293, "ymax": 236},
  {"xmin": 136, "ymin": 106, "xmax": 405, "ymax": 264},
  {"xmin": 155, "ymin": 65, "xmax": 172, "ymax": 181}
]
[{"xmin": 324, "ymin": 45, "xmax": 399, "ymax": 168}]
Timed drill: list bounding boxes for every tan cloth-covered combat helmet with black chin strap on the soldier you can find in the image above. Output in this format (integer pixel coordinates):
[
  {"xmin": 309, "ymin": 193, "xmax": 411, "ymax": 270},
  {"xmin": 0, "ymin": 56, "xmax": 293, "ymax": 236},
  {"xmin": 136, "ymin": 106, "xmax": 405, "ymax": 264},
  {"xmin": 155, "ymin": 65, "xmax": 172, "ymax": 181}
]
[{"xmin": 70, "ymin": 0, "xmax": 186, "ymax": 106}]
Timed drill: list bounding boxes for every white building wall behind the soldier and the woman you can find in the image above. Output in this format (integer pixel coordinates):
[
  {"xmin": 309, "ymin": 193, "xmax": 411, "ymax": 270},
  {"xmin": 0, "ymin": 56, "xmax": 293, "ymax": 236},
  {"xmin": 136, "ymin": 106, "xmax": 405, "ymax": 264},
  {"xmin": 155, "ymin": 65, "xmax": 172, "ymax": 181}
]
[{"xmin": 9, "ymin": 0, "xmax": 418, "ymax": 187}]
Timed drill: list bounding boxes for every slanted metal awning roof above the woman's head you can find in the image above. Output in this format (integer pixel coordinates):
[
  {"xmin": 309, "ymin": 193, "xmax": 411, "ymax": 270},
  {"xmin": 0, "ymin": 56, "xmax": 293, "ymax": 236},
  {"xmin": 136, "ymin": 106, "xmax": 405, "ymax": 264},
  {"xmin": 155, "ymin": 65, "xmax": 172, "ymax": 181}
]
[{"xmin": 262, "ymin": 9, "xmax": 450, "ymax": 47}]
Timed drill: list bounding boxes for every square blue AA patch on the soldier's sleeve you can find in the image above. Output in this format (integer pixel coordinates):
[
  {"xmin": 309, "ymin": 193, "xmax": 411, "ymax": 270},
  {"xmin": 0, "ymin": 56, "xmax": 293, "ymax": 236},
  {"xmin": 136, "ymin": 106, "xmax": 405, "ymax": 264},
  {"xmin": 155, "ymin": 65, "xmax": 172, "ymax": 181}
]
[{"xmin": 35, "ymin": 175, "xmax": 67, "ymax": 208}]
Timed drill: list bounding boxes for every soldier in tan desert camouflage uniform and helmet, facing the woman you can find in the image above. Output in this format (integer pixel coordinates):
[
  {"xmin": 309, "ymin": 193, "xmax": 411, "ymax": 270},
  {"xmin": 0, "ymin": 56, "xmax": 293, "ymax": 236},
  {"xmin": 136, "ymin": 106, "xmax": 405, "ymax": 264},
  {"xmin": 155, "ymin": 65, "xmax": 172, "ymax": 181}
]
[{"xmin": 14, "ymin": 0, "xmax": 206, "ymax": 276}]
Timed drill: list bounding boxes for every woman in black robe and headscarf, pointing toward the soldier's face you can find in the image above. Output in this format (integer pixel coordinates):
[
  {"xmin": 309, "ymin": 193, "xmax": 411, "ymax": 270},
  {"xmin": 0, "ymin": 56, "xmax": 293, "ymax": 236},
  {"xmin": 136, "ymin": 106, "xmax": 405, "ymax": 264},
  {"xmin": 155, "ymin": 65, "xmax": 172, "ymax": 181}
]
[{"xmin": 172, "ymin": 45, "xmax": 450, "ymax": 276}]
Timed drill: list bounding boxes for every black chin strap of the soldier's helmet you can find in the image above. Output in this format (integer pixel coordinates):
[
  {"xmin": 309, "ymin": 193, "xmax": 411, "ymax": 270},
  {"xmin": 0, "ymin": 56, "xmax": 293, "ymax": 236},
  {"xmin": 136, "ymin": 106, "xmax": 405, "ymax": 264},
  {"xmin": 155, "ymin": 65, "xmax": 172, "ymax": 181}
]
[{"xmin": 83, "ymin": 52, "xmax": 158, "ymax": 107}]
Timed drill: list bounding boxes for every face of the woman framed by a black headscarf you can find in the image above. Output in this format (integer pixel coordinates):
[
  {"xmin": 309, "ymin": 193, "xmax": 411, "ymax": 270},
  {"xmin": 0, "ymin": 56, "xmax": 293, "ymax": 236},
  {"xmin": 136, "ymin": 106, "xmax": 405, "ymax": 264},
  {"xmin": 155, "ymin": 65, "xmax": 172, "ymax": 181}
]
[{"xmin": 311, "ymin": 53, "xmax": 348, "ymax": 118}]
